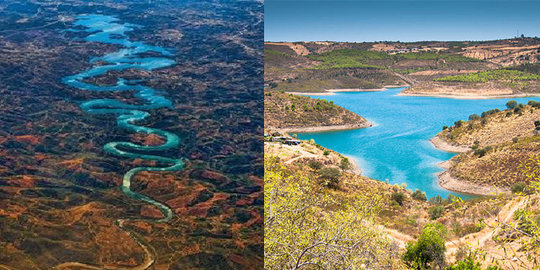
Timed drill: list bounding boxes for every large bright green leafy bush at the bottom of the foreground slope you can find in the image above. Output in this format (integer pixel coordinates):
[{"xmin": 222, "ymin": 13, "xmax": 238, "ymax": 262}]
[{"xmin": 403, "ymin": 223, "xmax": 446, "ymax": 269}]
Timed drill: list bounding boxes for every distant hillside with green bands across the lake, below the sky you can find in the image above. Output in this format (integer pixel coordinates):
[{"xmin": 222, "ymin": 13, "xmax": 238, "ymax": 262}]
[{"xmin": 265, "ymin": 37, "xmax": 540, "ymax": 97}]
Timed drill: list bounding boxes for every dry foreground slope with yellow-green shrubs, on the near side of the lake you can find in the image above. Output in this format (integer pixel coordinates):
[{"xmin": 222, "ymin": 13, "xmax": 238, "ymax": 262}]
[{"xmin": 265, "ymin": 130, "xmax": 540, "ymax": 269}]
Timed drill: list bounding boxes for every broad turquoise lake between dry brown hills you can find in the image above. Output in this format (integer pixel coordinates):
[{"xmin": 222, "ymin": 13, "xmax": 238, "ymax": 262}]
[{"xmin": 298, "ymin": 88, "xmax": 540, "ymax": 197}]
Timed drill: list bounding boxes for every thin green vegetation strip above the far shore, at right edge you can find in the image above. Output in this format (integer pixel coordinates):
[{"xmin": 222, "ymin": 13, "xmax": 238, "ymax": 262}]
[{"xmin": 434, "ymin": 69, "xmax": 540, "ymax": 83}]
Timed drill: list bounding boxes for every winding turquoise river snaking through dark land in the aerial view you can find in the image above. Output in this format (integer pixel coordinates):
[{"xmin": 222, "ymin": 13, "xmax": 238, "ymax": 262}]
[{"xmin": 63, "ymin": 14, "xmax": 184, "ymax": 222}]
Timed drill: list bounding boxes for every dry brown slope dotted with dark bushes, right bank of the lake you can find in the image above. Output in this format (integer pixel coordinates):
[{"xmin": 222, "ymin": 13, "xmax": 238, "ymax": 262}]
[{"xmin": 438, "ymin": 101, "xmax": 540, "ymax": 189}]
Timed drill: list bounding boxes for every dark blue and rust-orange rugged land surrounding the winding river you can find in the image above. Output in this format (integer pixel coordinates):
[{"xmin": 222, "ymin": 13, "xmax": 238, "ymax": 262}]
[{"xmin": 0, "ymin": 0, "xmax": 263, "ymax": 269}]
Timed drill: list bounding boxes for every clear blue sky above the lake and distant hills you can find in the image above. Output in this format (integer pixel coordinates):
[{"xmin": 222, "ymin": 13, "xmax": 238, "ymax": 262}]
[{"xmin": 264, "ymin": 0, "xmax": 540, "ymax": 42}]
